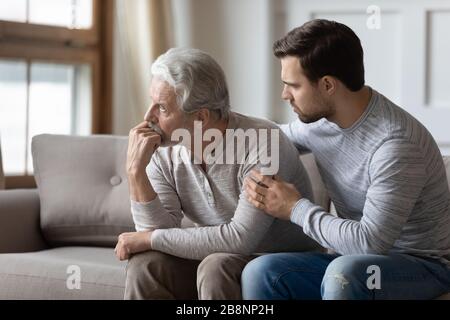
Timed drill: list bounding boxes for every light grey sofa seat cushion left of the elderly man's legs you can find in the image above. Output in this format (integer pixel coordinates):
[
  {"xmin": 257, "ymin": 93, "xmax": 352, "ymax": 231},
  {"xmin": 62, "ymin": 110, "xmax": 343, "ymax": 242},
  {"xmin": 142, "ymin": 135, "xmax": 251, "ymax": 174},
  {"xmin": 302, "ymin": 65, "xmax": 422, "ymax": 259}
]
[{"xmin": 0, "ymin": 247, "xmax": 126, "ymax": 300}]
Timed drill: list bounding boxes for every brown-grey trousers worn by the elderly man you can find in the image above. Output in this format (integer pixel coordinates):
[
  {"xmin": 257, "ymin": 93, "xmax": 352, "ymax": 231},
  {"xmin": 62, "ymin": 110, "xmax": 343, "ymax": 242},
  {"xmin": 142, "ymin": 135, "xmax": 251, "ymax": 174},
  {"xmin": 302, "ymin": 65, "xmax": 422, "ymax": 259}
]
[{"xmin": 124, "ymin": 251, "xmax": 257, "ymax": 300}]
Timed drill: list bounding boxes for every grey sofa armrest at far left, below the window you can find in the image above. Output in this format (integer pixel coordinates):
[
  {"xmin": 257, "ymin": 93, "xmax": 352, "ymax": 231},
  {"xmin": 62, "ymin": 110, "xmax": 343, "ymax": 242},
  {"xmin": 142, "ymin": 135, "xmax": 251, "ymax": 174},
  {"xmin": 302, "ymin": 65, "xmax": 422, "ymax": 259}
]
[{"xmin": 0, "ymin": 189, "xmax": 47, "ymax": 253}]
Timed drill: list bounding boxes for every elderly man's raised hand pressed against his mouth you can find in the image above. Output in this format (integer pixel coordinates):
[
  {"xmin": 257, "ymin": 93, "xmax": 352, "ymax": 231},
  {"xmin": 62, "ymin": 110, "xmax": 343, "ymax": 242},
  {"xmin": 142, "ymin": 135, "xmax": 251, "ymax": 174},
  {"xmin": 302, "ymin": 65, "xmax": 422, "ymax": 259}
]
[{"xmin": 127, "ymin": 121, "xmax": 161, "ymax": 173}]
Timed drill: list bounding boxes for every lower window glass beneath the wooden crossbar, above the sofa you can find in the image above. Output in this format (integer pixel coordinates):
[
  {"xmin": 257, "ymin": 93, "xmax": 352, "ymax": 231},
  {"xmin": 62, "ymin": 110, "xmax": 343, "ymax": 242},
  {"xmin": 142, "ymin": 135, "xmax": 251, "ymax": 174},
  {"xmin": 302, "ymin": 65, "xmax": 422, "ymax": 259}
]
[{"xmin": 0, "ymin": 60, "xmax": 92, "ymax": 175}]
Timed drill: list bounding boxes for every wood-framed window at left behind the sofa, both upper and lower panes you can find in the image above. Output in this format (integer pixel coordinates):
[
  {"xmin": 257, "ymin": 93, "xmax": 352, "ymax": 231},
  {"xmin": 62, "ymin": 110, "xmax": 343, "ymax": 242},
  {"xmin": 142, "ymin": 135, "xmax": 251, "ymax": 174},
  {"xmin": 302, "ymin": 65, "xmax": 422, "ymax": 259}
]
[{"xmin": 0, "ymin": 0, "xmax": 113, "ymax": 188}]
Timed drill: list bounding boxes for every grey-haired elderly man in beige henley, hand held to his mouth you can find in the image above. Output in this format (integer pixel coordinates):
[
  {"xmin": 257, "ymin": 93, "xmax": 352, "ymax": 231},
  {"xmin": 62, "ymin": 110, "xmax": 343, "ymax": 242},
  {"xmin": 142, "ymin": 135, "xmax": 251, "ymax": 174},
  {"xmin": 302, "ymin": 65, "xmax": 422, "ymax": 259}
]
[{"xmin": 116, "ymin": 49, "xmax": 318, "ymax": 299}]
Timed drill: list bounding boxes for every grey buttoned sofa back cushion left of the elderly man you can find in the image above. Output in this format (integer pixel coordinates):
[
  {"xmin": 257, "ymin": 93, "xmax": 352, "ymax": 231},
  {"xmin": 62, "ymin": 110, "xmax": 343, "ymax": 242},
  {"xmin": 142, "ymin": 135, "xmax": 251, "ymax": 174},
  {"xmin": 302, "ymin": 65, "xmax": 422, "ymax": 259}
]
[{"xmin": 31, "ymin": 134, "xmax": 134, "ymax": 247}]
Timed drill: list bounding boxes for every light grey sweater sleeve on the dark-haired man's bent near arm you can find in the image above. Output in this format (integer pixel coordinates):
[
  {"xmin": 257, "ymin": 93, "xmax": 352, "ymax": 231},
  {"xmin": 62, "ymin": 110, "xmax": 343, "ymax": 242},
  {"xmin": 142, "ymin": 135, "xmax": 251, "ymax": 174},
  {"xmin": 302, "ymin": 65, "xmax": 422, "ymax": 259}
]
[{"xmin": 291, "ymin": 139, "xmax": 426, "ymax": 254}]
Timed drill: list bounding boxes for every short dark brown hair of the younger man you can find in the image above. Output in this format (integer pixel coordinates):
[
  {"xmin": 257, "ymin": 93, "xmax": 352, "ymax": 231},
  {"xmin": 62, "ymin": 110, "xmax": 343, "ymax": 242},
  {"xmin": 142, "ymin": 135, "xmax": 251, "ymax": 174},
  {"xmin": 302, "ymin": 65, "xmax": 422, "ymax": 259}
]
[{"xmin": 273, "ymin": 19, "xmax": 364, "ymax": 91}]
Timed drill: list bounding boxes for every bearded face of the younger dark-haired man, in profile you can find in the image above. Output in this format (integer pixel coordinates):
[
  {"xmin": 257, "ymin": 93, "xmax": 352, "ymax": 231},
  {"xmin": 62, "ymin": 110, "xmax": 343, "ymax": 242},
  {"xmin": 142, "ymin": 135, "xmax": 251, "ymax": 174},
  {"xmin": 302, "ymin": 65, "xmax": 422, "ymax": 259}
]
[{"xmin": 281, "ymin": 56, "xmax": 333, "ymax": 123}]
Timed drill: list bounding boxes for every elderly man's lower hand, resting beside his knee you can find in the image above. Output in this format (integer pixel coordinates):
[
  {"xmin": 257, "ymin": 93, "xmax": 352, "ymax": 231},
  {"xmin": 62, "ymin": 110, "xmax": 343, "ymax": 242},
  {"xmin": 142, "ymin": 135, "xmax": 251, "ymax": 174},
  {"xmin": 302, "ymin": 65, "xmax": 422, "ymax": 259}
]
[{"xmin": 114, "ymin": 231, "xmax": 152, "ymax": 261}]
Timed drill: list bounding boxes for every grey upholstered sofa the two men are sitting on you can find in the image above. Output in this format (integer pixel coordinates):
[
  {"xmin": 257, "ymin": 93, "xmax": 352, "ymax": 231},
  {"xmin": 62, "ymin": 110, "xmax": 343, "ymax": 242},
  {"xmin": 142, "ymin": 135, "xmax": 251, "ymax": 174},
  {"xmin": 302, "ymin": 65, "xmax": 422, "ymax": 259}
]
[{"xmin": 0, "ymin": 134, "xmax": 450, "ymax": 300}]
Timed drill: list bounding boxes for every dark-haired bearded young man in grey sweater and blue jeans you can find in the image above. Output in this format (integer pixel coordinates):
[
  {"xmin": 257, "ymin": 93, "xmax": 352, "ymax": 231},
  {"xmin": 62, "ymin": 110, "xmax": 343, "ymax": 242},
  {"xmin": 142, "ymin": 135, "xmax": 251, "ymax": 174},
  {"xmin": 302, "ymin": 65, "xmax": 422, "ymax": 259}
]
[{"xmin": 242, "ymin": 20, "xmax": 450, "ymax": 299}]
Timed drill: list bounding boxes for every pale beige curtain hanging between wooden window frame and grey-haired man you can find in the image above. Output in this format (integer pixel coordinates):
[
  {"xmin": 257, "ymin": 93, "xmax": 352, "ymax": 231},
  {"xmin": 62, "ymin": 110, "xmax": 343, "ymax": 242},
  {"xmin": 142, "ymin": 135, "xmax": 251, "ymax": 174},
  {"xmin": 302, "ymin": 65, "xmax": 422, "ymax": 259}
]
[{"xmin": 114, "ymin": 0, "xmax": 173, "ymax": 134}]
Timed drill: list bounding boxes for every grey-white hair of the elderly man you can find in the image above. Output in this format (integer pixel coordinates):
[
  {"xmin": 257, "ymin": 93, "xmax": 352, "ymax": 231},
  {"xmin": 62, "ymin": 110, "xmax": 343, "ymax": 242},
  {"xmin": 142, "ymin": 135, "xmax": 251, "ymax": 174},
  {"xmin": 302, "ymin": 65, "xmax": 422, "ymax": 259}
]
[{"xmin": 151, "ymin": 48, "xmax": 230, "ymax": 119}]
